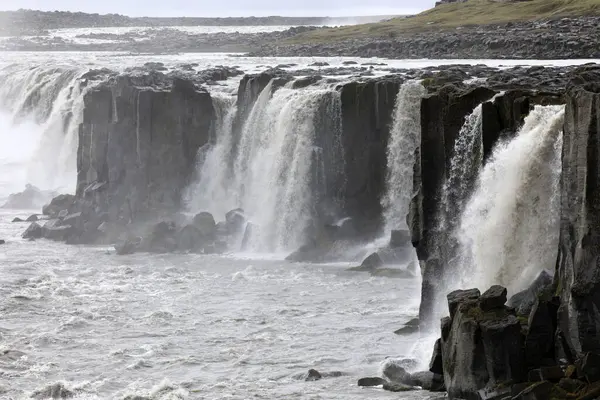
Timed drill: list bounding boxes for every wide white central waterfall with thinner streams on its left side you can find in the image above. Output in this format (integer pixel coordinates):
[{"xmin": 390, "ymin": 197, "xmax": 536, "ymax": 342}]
[{"xmin": 187, "ymin": 82, "xmax": 341, "ymax": 252}]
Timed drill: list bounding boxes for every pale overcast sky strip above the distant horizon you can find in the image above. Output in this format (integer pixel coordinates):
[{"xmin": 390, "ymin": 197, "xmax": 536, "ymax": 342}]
[{"xmin": 0, "ymin": 0, "xmax": 435, "ymax": 17}]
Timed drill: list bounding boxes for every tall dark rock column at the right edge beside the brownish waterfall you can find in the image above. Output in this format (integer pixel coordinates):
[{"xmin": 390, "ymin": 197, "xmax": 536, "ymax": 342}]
[{"xmin": 557, "ymin": 80, "xmax": 600, "ymax": 353}]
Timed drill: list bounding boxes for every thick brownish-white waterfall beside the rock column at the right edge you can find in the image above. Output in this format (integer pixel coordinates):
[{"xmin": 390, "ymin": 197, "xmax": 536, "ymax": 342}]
[{"xmin": 457, "ymin": 106, "xmax": 564, "ymax": 293}]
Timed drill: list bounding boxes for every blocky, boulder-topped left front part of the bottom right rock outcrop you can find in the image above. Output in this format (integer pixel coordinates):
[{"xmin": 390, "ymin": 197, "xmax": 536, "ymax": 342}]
[{"xmin": 441, "ymin": 287, "xmax": 525, "ymax": 399}]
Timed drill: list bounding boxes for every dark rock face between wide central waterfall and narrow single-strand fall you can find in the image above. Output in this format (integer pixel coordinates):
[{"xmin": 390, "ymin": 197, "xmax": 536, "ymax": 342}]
[{"xmin": 339, "ymin": 79, "xmax": 402, "ymax": 229}]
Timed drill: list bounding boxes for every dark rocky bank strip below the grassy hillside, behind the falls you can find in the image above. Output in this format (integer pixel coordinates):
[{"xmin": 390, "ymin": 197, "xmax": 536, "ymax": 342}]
[{"xmin": 251, "ymin": 17, "xmax": 600, "ymax": 60}]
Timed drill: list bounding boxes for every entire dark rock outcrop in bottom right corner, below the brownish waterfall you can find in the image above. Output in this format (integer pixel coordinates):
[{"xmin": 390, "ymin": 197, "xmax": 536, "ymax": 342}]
[{"xmin": 430, "ymin": 284, "xmax": 600, "ymax": 400}]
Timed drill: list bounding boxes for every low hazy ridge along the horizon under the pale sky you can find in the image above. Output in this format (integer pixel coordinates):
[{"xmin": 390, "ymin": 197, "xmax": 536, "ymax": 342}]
[{"xmin": 0, "ymin": 9, "xmax": 397, "ymax": 36}]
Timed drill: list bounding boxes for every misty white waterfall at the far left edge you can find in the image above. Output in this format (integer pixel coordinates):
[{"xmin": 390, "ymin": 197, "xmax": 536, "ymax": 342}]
[{"xmin": 0, "ymin": 64, "xmax": 86, "ymax": 194}]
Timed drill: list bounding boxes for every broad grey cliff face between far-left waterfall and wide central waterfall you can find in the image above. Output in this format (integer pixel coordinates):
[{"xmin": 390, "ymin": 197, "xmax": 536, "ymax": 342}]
[{"xmin": 77, "ymin": 72, "xmax": 214, "ymax": 222}]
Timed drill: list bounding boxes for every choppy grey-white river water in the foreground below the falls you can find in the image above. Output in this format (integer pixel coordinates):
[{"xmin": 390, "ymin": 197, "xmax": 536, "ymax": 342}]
[{"xmin": 0, "ymin": 211, "xmax": 427, "ymax": 399}]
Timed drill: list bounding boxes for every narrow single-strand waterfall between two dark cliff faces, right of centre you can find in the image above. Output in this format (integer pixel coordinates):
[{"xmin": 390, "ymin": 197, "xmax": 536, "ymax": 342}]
[{"xmin": 381, "ymin": 81, "xmax": 426, "ymax": 235}]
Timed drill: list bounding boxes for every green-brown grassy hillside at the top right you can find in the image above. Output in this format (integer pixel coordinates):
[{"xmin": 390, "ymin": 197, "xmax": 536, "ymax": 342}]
[{"xmin": 291, "ymin": 0, "xmax": 600, "ymax": 42}]
